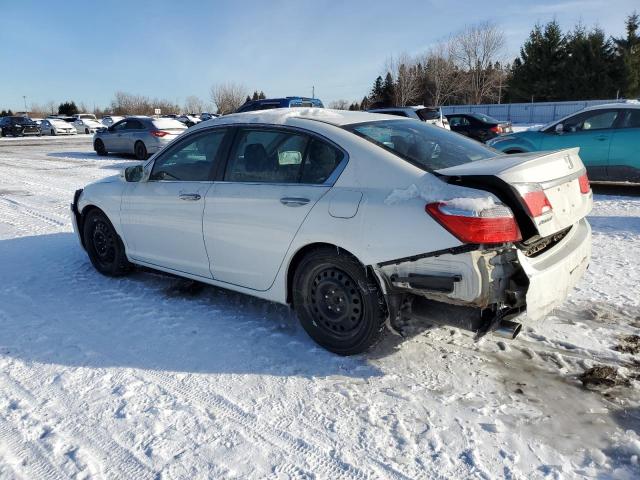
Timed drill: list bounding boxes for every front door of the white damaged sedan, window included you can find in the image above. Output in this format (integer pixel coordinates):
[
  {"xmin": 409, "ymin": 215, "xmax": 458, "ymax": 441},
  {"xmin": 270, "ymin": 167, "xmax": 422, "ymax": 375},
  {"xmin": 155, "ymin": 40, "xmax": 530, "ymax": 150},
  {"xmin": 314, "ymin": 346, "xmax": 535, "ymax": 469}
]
[{"xmin": 120, "ymin": 129, "xmax": 226, "ymax": 278}]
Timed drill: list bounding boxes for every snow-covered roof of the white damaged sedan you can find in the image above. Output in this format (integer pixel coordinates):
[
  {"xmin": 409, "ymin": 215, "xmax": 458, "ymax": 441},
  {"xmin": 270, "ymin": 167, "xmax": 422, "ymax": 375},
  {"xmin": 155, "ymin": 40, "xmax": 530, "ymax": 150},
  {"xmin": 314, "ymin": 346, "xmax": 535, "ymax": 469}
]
[{"xmin": 193, "ymin": 107, "xmax": 403, "ymax": 129}]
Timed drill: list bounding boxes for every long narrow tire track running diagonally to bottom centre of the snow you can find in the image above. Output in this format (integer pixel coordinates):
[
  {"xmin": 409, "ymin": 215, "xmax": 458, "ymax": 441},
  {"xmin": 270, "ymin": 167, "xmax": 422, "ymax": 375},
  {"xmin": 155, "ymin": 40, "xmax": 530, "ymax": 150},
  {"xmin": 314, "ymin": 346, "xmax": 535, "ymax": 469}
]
[{"xmin": 137, "ymin": 371, "xmax": 370, "ymax": 480}]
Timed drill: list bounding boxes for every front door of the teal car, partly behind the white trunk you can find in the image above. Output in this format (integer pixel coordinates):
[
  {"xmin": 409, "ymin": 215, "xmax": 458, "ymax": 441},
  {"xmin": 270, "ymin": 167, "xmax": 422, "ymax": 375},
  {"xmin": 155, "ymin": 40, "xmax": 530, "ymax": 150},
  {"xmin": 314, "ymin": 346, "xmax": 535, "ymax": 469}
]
[{"xmin": 541, "ymin": 109, "xmax": 620, "ymax": 180}]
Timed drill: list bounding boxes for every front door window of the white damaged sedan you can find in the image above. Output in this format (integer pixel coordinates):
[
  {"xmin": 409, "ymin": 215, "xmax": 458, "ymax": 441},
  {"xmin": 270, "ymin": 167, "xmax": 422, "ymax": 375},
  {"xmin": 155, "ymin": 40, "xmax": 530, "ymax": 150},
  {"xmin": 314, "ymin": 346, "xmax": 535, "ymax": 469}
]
[{"xmin": 149, "ymin": 129, "xmax": 226, "ymax": 182}]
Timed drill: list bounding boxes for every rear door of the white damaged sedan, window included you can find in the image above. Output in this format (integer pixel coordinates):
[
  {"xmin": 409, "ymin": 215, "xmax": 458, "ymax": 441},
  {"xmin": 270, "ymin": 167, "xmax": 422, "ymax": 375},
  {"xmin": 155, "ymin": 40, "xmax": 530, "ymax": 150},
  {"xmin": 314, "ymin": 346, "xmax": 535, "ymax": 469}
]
[{"xmin": 203, "ymin": 127, "xmax": 346, "ymax": 290}]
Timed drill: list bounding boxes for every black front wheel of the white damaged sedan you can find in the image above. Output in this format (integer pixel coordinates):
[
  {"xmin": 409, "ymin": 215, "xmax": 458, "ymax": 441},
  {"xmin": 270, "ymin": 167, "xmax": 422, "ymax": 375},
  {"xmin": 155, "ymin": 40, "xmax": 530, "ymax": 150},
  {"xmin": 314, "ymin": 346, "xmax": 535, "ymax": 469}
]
[{"xmin": 82, "ymin": 210, "xmax": 132, "ymax": 277}]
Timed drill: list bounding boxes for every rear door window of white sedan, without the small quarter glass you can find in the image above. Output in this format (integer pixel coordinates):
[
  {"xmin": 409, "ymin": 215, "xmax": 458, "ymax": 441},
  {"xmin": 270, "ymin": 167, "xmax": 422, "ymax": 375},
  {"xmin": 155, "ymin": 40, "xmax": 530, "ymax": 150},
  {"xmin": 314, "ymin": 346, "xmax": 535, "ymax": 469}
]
[{"xmin": 224, "ymin": 129, "xmax": 309, "ymax": 183}]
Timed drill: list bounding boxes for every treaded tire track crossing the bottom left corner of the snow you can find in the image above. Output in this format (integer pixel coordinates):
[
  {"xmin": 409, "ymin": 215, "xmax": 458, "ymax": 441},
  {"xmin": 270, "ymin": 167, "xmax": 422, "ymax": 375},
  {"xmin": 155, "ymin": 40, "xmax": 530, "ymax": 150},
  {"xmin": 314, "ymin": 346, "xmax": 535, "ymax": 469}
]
[{"xmin": 0, "ymin": 417, "xmax": 67, "ymax": 480}]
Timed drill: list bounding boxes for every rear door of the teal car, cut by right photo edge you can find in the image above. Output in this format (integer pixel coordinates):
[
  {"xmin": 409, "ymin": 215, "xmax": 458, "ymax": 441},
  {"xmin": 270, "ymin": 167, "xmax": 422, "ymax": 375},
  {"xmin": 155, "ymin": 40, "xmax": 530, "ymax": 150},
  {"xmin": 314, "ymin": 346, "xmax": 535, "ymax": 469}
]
[{"xmin": 607, "ymin": 108, "xmax": 640, "ymax": 182}]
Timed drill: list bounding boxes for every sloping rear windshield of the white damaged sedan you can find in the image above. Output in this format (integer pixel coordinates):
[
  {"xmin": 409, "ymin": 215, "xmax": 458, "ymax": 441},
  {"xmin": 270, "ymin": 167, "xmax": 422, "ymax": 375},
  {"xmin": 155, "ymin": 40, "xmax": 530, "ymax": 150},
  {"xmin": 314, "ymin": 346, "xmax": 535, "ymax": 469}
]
[{"xmin": 344, "ymin": 120, "xmax": 499, "ymax": 171}]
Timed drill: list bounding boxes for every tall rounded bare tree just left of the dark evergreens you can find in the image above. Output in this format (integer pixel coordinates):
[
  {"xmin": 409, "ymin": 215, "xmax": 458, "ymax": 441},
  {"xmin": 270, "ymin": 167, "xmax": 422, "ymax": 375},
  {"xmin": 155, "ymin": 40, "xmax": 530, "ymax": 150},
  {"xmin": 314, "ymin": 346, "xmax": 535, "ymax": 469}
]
[{"xmin": 453, "ymin": 22, "xmax": 505, "ymax": 104}]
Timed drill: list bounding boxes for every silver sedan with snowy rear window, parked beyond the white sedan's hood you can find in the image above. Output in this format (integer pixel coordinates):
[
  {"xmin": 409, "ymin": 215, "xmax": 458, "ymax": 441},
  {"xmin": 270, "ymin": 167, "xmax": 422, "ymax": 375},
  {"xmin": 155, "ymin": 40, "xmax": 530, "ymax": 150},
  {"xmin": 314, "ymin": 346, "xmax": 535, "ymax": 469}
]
[{"xmin": 93, "ymin": 117, "xmax": 187, "ymax": 160}]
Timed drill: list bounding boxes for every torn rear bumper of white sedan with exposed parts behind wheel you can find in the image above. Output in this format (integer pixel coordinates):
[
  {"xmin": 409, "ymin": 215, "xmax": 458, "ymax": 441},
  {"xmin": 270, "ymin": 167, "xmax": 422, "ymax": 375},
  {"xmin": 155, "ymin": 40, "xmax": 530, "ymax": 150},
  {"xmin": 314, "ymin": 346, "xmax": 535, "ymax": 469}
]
[{"xmin": 373, "ymin": 219, "xmax": 591, "ymax": 338}]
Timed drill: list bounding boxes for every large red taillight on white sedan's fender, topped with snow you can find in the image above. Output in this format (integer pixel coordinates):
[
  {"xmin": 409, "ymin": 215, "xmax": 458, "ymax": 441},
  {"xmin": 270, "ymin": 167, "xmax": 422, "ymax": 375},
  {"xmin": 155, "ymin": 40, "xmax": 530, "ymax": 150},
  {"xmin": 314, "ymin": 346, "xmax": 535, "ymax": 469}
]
[{"xmin": 425, "ymin": 202, "xmax": 522, "ymax": 244}]
